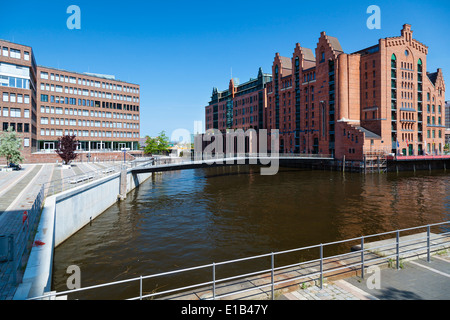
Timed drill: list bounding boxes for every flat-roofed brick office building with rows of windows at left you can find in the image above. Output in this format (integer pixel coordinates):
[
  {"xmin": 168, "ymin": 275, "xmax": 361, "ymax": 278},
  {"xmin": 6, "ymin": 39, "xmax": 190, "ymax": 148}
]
[{"xmin": 0, "ymin": 40, "xmax": 140, "ymax": 163}]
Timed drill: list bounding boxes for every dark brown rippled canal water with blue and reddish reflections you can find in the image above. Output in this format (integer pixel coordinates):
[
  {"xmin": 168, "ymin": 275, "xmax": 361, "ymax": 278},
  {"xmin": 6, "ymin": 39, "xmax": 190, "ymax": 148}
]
[{"xmin": 53, "ymin": 166, "xmax": 450, "ymax": 299}]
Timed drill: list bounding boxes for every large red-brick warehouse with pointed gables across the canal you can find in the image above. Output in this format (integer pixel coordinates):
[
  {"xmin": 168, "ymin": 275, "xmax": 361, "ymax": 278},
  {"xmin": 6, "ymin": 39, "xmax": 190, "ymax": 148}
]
[{"xmin": 206, "ymin": 24, "xmax": 445, "ymax": 160}]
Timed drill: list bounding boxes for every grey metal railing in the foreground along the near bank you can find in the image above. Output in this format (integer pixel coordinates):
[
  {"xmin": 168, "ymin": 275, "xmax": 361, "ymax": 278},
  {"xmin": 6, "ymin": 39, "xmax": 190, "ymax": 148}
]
[{"xmin": 30, "ymin": 221, "xmax": 450, "ymax": 300}]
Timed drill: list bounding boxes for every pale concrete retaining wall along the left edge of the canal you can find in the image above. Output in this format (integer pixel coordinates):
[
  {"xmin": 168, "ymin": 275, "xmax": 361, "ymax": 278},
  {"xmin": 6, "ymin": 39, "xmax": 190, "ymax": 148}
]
[{"xmin": 14, "ymin": 166, "xmax": 152, "ymax": 300}]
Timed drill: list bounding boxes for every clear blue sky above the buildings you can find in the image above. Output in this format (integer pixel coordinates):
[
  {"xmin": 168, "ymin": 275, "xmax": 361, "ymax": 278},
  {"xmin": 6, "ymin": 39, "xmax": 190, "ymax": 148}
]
[{"xmin": 0, "ymin": 0, "xmax": 450, "ymax": 136}]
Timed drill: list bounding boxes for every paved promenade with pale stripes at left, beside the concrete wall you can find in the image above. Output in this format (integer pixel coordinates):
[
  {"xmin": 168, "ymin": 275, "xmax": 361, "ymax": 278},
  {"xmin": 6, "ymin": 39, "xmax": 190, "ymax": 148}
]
[{"xmin": 0, "ymin": 162, "xmax": 123, "ymax": 300}]
